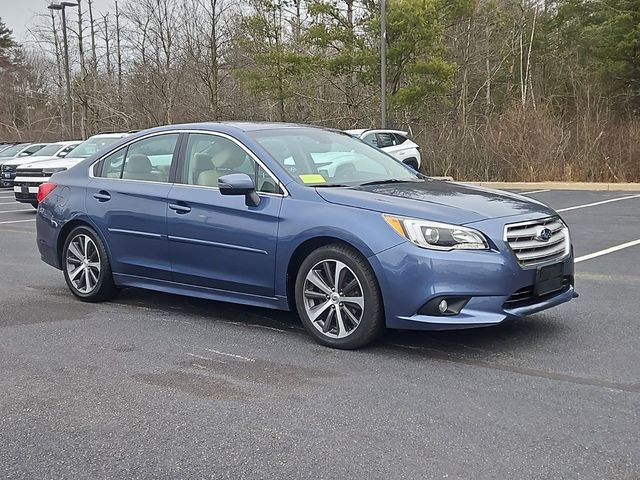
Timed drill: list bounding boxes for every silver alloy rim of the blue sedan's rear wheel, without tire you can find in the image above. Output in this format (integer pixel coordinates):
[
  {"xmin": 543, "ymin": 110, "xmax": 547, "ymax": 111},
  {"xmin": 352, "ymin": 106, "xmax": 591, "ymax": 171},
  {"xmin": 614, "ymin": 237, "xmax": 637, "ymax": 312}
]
[{"xmin": 66, "ymin": 233, "xmax": 101, "ymax": 294}]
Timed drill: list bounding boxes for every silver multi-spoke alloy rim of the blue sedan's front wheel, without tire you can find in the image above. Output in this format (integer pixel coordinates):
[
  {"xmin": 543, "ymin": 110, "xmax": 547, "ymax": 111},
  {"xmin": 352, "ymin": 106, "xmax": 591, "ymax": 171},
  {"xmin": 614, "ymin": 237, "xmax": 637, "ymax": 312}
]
[{"xmin": 303, "ymin": 259, "xmax": 364, "ymax": 338}]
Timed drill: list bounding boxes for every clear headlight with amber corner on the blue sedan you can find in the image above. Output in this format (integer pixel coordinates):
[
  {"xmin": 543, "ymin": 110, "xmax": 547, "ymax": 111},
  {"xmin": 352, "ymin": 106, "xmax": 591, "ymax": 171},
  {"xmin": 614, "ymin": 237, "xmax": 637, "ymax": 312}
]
[{"xmin": 383, "ymin": 215, "xmax": 489, "ymax": 250}]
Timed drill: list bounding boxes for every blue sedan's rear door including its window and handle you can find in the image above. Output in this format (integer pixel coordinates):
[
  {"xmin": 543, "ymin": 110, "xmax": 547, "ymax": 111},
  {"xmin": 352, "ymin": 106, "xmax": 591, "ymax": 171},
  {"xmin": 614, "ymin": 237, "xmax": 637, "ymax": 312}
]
[{"xmin": 86, "ymin": 133, "xmax": 180, "ymax": 280}]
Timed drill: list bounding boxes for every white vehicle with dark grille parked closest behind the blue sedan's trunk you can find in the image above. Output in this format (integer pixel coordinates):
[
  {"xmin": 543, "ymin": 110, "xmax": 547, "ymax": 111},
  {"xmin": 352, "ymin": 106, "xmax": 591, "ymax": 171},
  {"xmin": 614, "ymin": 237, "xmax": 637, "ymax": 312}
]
[{"xmin": 13, "ymin": 133, "xmax": 129, "ymax": 208}]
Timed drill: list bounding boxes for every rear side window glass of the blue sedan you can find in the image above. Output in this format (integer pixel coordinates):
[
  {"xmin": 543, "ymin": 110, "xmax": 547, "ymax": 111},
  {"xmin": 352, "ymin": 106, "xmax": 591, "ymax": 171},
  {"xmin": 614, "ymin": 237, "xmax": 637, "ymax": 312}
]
[{"xmin": 96, "ymin": 133, "xmax": 179, "ymax": 182}]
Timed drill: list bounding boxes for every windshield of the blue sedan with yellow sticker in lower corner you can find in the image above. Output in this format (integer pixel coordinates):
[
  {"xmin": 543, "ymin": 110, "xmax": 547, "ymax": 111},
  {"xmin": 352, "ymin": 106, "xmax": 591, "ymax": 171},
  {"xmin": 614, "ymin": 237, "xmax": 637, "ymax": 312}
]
[{"xmin": 250, "ymin": 128, "xmax": 421, "ymax": 186}]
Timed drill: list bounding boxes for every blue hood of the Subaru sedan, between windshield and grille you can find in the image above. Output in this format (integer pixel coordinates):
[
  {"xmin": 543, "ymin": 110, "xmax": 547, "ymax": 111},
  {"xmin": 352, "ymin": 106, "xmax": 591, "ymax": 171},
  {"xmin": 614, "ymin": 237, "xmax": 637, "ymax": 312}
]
[{"xmin": 316, "ymin": 179, "xmax": 555, "ymax": 225}]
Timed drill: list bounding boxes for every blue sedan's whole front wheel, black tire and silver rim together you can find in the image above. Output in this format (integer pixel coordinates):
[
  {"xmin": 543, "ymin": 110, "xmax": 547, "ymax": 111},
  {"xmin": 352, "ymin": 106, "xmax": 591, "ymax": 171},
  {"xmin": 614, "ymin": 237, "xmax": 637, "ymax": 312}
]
[{"xmin": 295, "ymin": 244, "xmax": 385, "ymax": 349}]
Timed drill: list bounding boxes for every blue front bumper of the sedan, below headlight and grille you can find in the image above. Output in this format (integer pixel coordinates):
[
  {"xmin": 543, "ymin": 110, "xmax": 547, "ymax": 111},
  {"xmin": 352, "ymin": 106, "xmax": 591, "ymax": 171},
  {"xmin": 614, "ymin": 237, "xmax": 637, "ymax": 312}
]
[{"xmin": 369, "ymin": 235, "xmax": 575, "ymax": 330}]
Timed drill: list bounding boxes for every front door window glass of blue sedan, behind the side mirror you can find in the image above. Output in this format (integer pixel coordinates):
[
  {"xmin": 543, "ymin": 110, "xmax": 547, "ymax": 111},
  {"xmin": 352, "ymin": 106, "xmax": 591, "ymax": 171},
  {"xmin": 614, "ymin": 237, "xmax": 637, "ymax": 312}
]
[{"xmin": 181, "ymin": 133, "xmax": 282, "ymax": 193}]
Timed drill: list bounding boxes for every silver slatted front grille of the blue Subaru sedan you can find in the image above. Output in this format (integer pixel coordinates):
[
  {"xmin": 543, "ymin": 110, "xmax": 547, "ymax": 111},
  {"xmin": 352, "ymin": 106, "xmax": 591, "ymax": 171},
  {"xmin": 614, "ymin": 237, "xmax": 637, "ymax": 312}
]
[{"xmin": 504, "ymin": 217, "xmax": 570, "ymax": 266}]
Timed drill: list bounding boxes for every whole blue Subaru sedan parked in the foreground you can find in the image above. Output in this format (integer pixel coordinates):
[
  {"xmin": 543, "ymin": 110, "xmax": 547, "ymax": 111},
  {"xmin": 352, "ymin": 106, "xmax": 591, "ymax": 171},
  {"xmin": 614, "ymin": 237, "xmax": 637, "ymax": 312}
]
[{"xmin": 37, "ymin": 123, "xmax": 575, "ymax": 348}]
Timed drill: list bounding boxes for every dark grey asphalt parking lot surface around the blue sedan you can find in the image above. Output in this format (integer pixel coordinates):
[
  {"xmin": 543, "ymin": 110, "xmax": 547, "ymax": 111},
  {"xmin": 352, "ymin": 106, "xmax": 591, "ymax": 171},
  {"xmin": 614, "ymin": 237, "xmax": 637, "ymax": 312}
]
[{"xmin": 0, "ymin": 190, "xmax": 640, "ymax": 479}]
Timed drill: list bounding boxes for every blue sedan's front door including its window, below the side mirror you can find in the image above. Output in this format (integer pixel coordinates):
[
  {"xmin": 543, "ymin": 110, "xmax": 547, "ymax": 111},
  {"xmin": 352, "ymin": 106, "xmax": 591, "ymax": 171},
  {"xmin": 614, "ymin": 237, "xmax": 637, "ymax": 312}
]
[{"xmin": 167, "ymin": 133, "xmax": 284, "ymax": 296}]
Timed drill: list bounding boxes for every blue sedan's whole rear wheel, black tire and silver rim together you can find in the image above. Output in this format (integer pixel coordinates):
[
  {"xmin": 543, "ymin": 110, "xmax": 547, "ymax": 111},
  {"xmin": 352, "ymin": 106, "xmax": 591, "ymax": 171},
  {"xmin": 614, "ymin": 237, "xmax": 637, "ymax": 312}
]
[{"xmin": 61, "ymin": 226, "xmax": 117, "ymax": 302}]
